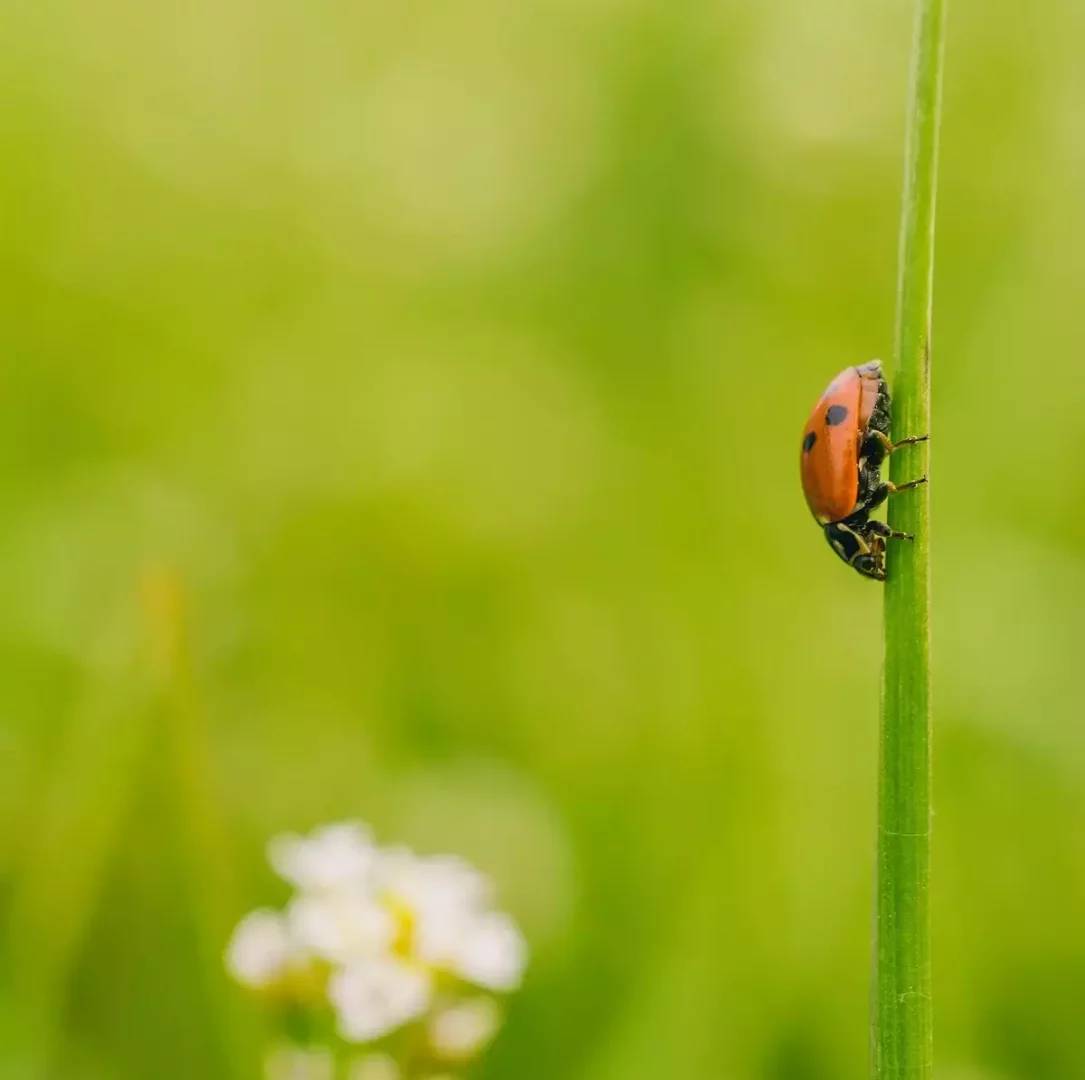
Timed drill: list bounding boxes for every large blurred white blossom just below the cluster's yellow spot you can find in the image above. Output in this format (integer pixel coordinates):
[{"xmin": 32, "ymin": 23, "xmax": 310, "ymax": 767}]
[{"xmin": 328, "ymin": 957, "xmax": 433, "ymax": 1042}]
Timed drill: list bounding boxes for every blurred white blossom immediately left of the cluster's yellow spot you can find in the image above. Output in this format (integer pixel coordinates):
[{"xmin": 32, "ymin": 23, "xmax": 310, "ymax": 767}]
[{"xmin": 286, "ymin": 889, "xmax": 396, "ymax": 964}]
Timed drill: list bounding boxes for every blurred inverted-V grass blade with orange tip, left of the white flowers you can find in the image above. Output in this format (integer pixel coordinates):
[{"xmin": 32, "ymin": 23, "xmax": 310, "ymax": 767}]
[{"xmin": 0, "ymin": 571, "xmax": 259, "ymax": 1080}]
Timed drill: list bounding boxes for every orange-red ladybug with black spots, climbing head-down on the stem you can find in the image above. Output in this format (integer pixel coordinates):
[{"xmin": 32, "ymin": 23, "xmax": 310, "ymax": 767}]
[{"xmin": 801, "ymin": 360, "xmax": 930, "ymax": 581}]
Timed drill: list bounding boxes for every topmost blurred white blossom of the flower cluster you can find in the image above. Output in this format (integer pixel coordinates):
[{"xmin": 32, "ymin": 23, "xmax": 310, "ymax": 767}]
[{"xmin": 268, "ymin": 822, "xmax": 376, "ymax": 892}]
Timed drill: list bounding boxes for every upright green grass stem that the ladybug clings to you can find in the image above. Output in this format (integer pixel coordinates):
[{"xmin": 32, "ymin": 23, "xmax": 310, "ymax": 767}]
[{"xmin": 872, "ymin": 0, "xmax": 945, "ymax": 1080}]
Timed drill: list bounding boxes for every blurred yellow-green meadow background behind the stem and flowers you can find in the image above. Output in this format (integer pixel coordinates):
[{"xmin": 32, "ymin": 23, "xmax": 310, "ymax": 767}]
[{"xmin": 0, "ymin": 0, "xmax": 1085, "ymax": 1080}]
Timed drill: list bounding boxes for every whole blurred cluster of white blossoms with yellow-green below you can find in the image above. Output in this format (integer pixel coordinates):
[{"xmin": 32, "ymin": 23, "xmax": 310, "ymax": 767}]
[{"xmin": 226, "ymin": 822, "xmax": 526, "ymax": 1080}]
